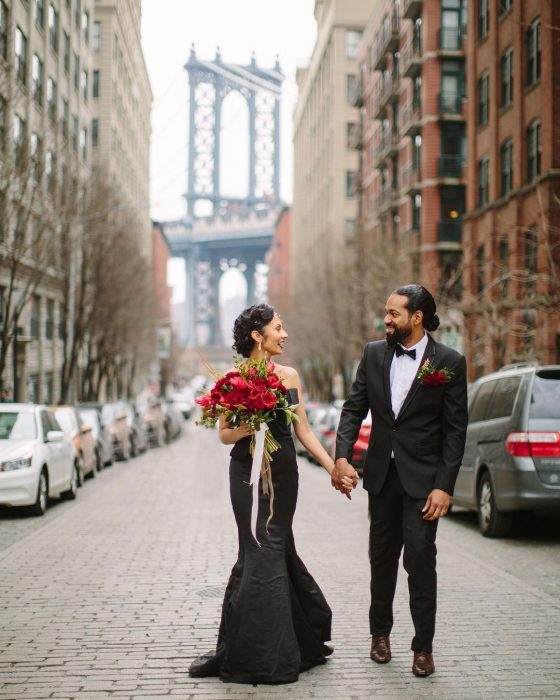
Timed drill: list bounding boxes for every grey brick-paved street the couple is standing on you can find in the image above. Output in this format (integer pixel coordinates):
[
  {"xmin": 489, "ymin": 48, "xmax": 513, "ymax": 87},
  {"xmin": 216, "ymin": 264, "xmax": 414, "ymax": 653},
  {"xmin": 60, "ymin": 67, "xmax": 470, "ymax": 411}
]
[{"xmin": 0, "ymin": 426, "xmax": 560, "ymax": 700}]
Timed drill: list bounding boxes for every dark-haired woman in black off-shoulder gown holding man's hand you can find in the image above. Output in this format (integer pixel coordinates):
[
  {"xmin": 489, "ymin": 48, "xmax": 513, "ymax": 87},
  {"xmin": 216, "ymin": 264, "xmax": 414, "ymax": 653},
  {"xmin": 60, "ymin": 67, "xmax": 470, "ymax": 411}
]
[{"xmin": 189, "ymin": 304, "xmax": 357, "ymax": 684}]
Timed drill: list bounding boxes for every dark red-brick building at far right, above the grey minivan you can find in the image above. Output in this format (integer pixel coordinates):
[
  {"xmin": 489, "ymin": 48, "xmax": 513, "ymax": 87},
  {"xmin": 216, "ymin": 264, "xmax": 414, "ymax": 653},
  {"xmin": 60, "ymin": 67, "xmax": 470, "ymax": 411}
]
[{"xmin": 463, "ymin": 0, "xmax": 560, "ymax": 378}]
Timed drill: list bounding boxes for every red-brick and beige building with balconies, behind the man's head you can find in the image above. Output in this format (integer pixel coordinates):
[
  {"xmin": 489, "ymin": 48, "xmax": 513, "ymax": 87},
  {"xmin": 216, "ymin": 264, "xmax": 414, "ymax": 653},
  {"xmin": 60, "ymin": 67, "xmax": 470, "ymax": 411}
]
[{"xmin": 358, "ymin": 0, "xmax": 467, "ymax": 340}]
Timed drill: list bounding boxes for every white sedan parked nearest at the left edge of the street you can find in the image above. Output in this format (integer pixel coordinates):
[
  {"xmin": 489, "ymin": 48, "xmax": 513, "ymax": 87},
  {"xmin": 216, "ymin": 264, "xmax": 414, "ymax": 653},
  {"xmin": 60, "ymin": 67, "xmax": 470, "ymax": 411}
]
[{"xmin": 0, "ymin": 403, "xmax": 78, "ymax": 515}]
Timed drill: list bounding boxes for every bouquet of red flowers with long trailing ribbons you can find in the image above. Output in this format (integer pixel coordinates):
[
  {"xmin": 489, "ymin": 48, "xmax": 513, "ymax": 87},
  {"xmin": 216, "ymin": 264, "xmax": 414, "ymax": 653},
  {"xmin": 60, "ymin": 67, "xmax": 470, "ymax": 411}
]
[{"xmin": 196, "ymin": 360, "xmax": 299, "ymax": 539}]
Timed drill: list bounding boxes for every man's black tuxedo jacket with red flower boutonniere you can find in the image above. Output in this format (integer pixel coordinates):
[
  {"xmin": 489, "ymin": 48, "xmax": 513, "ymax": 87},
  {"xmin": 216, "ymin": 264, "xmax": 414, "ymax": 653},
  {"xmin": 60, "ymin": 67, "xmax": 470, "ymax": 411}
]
[{"xmin": 336, "ymin": 336, "xmax": 468, "ymax": 499}]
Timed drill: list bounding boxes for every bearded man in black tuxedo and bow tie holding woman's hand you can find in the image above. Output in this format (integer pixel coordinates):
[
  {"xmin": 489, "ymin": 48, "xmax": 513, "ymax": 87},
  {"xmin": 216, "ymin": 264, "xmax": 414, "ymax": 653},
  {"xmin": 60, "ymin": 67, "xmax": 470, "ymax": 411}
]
[{"xmin": 332, "ymin": 284, "xmax": 467, "ymax": 676}]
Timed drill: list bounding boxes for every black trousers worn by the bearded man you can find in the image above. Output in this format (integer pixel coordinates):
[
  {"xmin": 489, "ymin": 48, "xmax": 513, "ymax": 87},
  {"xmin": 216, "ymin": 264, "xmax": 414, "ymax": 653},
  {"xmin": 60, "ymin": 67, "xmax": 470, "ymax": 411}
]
[{"xmin": 369, "ymin": 460, "xmax": 438, "ymax": 652}]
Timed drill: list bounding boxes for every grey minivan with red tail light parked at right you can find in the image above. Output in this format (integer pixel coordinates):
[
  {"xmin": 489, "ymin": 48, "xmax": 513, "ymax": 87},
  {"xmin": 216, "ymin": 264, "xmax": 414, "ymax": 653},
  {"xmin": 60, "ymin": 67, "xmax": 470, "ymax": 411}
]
[{"xmin": 453, "ymin": 365, "xmax": 560, "ymax": 537}]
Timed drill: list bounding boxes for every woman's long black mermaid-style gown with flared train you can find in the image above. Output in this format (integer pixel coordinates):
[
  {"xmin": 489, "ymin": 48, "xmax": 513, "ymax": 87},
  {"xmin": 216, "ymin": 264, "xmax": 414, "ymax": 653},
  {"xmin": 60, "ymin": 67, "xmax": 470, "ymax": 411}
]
[{"xmin": 189, "ymin": 400, "xmax": 332, "ymax": 684}]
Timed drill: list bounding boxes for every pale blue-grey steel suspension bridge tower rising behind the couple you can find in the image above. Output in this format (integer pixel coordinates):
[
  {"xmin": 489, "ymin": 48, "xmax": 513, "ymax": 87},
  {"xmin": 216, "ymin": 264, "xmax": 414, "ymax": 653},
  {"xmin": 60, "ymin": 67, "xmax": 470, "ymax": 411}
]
[{"xmin": 164, "ymin": 46, "xmax": 284, "ymax": 350}]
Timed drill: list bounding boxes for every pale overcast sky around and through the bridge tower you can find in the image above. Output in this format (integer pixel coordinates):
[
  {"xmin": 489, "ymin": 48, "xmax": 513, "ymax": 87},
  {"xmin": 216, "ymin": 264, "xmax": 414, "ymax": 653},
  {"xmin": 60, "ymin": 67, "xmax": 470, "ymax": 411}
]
[{"xmin": 142, "ymin": 0, "xmax": 315, "ymax": 221}]
